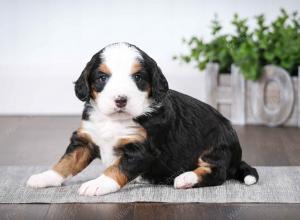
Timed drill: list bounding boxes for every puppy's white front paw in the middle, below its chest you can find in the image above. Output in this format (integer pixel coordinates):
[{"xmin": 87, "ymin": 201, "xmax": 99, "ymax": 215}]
[{"xmin": 78, "ymin": 174, "xmax": 121, "ymax": 196}]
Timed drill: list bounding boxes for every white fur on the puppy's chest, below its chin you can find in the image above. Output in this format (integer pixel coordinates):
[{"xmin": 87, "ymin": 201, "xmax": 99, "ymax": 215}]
[{"xmin": 82, "ymin": 115, "xmax": 140, "ymax": 167}]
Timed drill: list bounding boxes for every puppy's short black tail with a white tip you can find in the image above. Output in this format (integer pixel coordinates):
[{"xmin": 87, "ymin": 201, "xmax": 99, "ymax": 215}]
[{"xmin": 235, "ymin": 161, "xmax": 259, "ymax": 185}]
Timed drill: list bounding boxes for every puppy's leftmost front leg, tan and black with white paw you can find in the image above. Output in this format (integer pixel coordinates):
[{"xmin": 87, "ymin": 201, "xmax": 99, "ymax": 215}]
[{"xmin": 27, "ymin": 132, "xmax": 99, "ymax": 188}]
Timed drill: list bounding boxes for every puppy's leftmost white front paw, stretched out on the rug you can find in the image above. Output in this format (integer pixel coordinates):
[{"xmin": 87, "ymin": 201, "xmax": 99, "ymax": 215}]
[{"xmin": 27, "ymin": 170, "xmax": 64, "ymax": 188}]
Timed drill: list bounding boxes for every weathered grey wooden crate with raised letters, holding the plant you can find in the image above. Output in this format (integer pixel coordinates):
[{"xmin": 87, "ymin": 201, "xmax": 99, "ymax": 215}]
[{"xmin": 204, "ymin": 63, "xmax": 300, "ymax": 127}]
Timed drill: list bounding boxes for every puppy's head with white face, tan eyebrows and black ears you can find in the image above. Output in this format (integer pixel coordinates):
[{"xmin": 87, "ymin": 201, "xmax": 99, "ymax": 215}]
[{"xmin": 75, "ymin": 43, "xmax": 169, "ymax": 117}]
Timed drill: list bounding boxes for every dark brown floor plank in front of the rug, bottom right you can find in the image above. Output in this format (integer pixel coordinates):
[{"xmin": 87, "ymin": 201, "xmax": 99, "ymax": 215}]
[{"xmin": 134, "ymin": 203, "xmax": 300, "ymax": 220}]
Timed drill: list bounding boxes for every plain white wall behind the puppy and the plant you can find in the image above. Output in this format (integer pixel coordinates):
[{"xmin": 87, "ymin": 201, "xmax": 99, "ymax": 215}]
[{"xmin": 0, "ymin": 0, "xmax": 300, "ymax": 115}]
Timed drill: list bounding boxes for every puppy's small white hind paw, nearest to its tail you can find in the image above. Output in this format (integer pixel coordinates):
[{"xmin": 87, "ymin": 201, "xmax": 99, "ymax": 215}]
[{"xmin": 174, "ymin": 171, "xmax": 198, "ymax": 189}]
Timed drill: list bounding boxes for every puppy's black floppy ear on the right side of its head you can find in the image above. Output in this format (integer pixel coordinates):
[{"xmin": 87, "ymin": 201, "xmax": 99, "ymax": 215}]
[{"xmin": 151, "ymin": 59, "xmax": 169, "ymax": 103}]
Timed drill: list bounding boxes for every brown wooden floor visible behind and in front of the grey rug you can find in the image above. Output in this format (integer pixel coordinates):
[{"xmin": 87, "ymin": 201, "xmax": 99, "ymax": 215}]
[{"xmin": 0, "ymin": 117, "xmax": 300, "ymax": 220}]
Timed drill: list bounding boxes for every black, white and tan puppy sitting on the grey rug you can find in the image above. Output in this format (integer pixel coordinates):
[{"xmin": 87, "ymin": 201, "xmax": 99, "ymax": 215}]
[{"xmin": 27, "ymin": 43, "xmax": 258, "ymax": 196}]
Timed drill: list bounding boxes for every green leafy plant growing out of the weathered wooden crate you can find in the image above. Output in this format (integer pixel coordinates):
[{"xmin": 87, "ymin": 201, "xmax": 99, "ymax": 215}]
[{"xmin": 173, "ymin": 9, "xmax": 300, "ymax": 80}]
